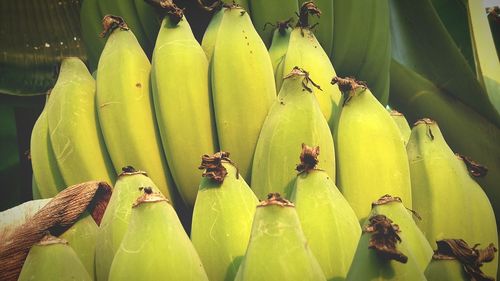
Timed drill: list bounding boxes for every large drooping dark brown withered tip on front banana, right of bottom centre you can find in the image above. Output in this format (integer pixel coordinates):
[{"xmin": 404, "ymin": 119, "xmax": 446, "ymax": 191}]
[{"xmin": 363, "ymin": 215, "xmax": 408, "ymax": 263}]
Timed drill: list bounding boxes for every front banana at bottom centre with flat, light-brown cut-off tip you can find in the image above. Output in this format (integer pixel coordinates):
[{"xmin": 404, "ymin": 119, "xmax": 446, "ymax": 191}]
[{"xmin": 234, "ymin": 193, "xmax": 326, "ymax": 281}]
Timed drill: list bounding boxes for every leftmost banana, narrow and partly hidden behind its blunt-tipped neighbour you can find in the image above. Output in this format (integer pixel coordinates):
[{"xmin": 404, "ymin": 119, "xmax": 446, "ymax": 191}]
[{"xmin": 30, "ymin": 96, "xmax": 66, "ymax": 198}]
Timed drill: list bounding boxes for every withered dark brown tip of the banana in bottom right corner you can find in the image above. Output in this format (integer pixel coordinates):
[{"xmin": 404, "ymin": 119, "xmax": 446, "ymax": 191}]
[{"xmin": 432, "ymin": 239, "xmax": 497, "ymax": 281}]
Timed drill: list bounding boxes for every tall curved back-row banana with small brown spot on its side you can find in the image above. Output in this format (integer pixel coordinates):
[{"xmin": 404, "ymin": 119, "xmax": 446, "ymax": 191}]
[{"xmin": 96, "ymin": 16, "xmax": 176, "ymax": 203}]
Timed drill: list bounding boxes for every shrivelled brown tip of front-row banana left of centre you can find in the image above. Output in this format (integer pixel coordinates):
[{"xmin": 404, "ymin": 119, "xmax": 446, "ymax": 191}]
[{"xmin": 198, "ymin": 151, "xmax": 239, "ymax": 183}]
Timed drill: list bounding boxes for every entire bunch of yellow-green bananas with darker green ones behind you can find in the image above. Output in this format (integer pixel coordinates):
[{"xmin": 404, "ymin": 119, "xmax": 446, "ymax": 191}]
[{"xmin": 20, "ymin": 0, "xmax": 500, "ymax": 281}]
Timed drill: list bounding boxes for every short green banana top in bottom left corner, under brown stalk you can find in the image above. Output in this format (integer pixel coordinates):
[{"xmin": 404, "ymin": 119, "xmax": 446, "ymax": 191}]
[{"xmin": 18, "ymin": 235, "xmax": 92, "ymax": 281}]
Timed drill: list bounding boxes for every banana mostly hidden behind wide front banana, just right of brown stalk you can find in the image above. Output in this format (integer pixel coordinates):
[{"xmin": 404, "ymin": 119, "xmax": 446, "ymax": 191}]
[{"xmin": 95, "ymin": 167, "xmax": 158, "ymax": 281}]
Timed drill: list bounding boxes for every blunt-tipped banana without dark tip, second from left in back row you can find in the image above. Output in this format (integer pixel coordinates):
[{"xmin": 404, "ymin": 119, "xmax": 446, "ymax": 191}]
[{"xmin": 47, "ymin": 58, "xmax": 116, "ymax": 186}]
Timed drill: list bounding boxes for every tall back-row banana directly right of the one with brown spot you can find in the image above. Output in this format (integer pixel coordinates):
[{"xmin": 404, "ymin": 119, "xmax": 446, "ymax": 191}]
[{"xmin": 151, "ymin": 5, "xmax": 217, "ymax": 208}]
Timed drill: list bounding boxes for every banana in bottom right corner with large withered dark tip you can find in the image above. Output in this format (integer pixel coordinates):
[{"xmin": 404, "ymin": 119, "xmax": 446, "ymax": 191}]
[{"xmin": 425, "ymin": 239, "xmax": 497, "ymax": 281}]
